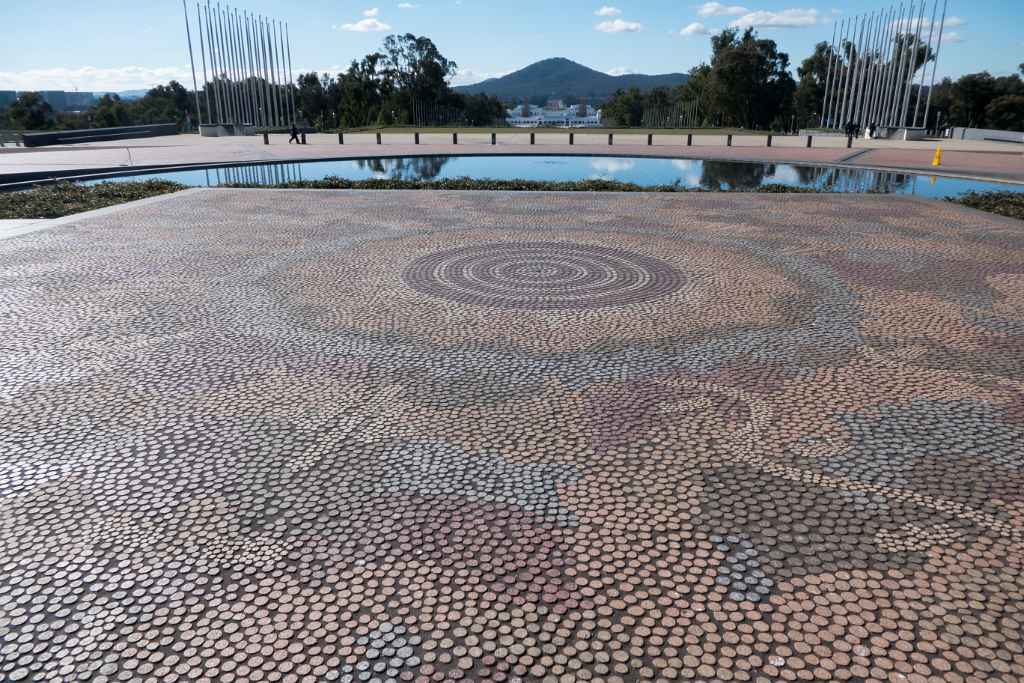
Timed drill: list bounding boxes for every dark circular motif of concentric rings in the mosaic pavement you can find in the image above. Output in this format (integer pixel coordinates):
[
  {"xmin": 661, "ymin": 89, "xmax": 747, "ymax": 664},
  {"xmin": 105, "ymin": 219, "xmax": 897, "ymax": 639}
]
[{"xmin": 402, "ymin": 242, "xmax": 685, "ymax": 310}]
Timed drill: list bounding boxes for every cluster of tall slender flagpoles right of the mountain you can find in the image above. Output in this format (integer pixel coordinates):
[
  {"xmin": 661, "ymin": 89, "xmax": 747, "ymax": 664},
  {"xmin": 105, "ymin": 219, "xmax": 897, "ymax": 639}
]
[{"xmin": 820, "ymin": 0, "xmax": 949, "ymax": 129}]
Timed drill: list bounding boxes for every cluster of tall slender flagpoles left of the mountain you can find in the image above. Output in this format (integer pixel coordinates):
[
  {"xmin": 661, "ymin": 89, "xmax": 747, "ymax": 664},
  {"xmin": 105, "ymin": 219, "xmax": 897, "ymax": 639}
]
[{"xmin": 181, "ymin": 0, "xmax": 296, "ymax": 132}]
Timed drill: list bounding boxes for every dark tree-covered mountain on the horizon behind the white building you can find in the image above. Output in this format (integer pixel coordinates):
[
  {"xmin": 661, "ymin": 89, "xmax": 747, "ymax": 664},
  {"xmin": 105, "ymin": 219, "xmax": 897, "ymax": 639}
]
[{"xmin": 455, "ymin": 57, "xmax": 689, "ymax": 101}]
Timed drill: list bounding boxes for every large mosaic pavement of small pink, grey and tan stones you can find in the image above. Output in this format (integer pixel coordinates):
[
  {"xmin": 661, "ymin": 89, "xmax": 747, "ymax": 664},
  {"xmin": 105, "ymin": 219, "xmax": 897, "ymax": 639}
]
[{"xmin": 0, "ymin": 190, "xmax": 1024, "ymax": 682}]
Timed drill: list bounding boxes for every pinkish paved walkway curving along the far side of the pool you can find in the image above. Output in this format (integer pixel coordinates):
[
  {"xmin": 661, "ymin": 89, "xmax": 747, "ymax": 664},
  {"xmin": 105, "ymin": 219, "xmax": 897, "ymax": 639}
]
[{"xmin": 0, "ymin": 133, "xmax": 1024, "ymax": 183}]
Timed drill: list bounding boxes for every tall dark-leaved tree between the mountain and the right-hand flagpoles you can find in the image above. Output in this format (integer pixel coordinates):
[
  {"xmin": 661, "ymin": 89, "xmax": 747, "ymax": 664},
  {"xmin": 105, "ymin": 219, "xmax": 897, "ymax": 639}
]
[{"xmin": 703, "ymin": 29, "xmax": 797, "ymax": 128}]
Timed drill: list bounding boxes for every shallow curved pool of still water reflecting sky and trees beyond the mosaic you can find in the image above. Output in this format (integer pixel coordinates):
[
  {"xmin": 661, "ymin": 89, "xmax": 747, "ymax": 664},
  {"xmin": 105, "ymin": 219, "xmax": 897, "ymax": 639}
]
[{"xmin": 92, "ymin": 156, "xmax": 1024, "ymax": 198}]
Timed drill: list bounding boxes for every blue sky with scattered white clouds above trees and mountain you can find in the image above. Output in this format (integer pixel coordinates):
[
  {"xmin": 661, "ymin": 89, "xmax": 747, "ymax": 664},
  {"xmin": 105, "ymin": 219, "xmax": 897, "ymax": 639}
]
[{"xmin": 0, "ymin": 0, "xmax": 1024, "ymax": 90}]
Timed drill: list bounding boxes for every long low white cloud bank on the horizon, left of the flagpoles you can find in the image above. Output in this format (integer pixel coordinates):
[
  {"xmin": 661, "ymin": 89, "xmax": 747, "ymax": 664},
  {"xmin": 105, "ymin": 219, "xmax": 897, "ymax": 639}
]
[{"xmin": 0, "ymin": 66, "xmax": 191, "ymax": 92}]
